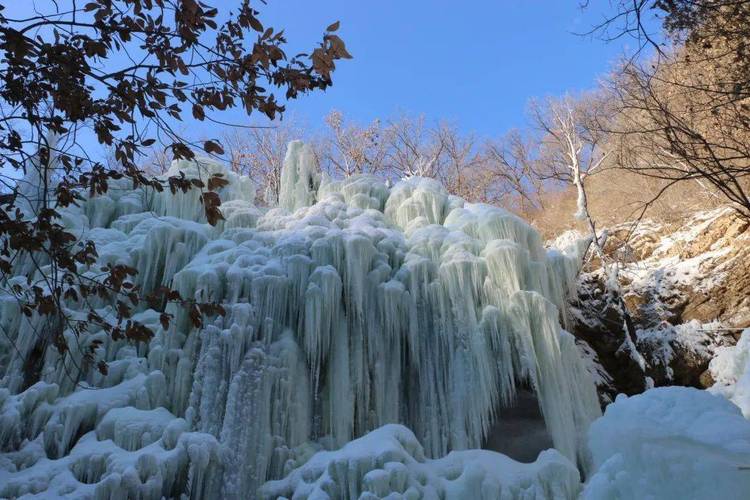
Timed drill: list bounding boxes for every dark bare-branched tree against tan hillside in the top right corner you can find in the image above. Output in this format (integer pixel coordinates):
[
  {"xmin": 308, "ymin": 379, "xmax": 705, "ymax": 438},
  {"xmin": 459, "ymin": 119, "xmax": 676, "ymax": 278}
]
[{"xmin": 595, "ymin": 0, "xmax": 750, "ymax": 217}]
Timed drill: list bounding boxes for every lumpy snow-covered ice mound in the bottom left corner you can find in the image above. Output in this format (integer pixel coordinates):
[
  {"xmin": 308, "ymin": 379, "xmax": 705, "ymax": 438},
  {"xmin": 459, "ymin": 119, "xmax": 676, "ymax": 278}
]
[{"xmin": 0, "ymin": 420, "xmax": 220, "ymax": 499}]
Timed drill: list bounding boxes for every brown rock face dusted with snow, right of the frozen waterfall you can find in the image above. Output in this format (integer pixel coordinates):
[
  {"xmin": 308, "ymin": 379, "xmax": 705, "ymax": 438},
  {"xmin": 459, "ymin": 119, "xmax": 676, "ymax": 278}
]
[{"xmin": 572, "ymin": 209, "xmax": 750, "ymax": 395}]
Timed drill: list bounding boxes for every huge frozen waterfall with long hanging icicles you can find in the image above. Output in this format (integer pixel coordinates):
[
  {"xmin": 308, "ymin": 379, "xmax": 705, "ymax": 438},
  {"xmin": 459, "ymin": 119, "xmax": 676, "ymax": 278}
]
[{"xmin": 0, "ymin": 142, "xmax": 600, "ymax": 498}]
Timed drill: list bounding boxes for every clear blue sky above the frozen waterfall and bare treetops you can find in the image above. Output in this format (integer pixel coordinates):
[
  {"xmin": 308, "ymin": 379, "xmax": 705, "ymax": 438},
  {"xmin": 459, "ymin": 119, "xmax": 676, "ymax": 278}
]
[{"xmin": 248, "ymin": 0, "xmax": 652, "ymax": 136}]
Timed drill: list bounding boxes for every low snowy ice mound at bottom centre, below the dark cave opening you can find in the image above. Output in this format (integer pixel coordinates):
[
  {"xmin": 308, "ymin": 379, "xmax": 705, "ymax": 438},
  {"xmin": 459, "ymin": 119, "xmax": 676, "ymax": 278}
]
[{"xmin": 260, "ymin": 424, "xmax": 580, "ymax": 500}]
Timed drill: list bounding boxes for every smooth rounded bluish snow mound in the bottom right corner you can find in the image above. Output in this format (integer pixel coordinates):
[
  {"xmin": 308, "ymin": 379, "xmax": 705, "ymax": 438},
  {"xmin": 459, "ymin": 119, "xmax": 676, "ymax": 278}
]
[{"xmin": 581, "ymin": 387, "xmax": 750, "ymax": 500}]
